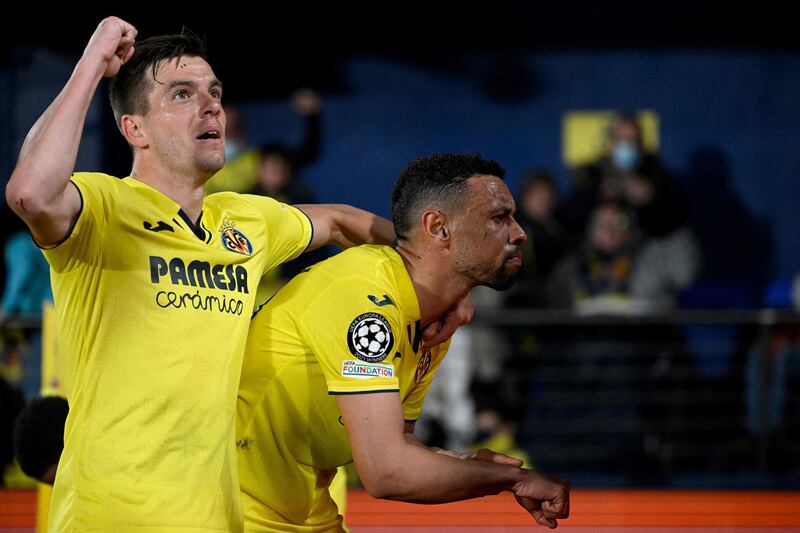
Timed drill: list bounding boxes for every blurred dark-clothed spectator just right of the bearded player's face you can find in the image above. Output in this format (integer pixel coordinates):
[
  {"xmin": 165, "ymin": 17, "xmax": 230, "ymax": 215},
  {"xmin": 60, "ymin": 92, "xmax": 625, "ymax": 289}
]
[{"xmin": 506, "ymin": 166, "xmax": 569, "ymax": 308}]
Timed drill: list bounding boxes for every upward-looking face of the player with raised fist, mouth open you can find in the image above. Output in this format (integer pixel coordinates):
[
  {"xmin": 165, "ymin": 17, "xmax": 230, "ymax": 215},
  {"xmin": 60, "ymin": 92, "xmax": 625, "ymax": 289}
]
[{"xmin": 143, "ymin": 56, "xmax": 225, "ymax": 181}]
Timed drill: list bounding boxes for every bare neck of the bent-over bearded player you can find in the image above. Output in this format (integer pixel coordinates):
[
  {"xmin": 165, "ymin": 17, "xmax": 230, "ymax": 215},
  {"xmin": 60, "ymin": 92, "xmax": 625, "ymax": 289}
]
[{"xmin": 395, "ymin": 243, "xmax": 472, "ymax": 326}]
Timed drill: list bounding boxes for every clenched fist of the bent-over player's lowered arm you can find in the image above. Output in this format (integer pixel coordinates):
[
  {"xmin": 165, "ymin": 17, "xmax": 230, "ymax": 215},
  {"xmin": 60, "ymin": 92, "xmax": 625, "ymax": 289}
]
[{"xmin": 512, "ymin": 470, "xmax": 569, "ymax": 529}]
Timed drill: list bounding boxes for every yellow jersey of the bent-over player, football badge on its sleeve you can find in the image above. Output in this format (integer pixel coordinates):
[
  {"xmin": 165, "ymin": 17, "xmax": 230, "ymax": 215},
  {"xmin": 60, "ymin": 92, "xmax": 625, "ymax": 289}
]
[{"xmin": 236, "ymin": 246, "xmax": 446, "ymax": 533}]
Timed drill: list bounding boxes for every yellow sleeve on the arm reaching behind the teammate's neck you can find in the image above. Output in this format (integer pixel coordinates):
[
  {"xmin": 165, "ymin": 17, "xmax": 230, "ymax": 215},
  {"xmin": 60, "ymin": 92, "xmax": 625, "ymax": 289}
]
[{"xmin": 243, "ymin": 194, "xmax": 314, "ymax": 271}]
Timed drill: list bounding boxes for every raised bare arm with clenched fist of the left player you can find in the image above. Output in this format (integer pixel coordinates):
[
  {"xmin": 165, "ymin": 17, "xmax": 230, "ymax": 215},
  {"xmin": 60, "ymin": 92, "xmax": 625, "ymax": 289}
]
[{"xmin": 6, "ymin": 17, "xmax": 136, "ymax": 246}]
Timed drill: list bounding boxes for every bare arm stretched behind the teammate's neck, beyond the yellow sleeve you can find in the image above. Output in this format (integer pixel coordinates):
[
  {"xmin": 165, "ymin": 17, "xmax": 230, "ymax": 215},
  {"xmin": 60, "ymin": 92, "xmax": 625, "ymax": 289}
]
[{"xmin": 295, "ymin": 204, "xmax": 395, "ymax": 251}]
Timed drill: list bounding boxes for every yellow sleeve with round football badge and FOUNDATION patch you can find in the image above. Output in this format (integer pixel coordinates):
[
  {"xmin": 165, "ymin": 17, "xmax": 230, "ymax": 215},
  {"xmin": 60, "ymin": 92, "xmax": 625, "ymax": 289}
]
[{"xmin": 300, "ymin": 276, "xmax": 402, "ymax": 394}]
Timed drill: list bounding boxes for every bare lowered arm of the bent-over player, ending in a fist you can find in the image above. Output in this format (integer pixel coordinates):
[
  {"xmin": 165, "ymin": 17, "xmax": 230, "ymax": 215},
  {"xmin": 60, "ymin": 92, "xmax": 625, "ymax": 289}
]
[{"xmin": 337, "ymin": 392, "xmax": 569, "ymax": 527}]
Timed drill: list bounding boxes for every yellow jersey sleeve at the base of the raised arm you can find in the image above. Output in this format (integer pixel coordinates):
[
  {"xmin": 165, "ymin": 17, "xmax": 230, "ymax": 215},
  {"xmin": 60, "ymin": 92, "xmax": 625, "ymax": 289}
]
[{"xmin": 42, "ymin": 172, "xmax": 122, "ymax": 272}]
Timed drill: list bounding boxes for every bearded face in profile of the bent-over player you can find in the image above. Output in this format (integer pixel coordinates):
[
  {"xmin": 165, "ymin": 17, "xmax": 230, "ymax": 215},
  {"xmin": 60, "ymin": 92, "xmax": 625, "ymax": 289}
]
[{"xmin": 451, "ymin": 176, "xmax": 526, "ymax": 290}]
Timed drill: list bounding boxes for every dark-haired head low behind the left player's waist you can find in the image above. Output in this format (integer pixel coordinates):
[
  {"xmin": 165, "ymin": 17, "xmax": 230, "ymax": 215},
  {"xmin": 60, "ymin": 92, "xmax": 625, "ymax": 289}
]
[{"xmin": 14, "ymin": 396, "xmax": 69, "ymax": 485}]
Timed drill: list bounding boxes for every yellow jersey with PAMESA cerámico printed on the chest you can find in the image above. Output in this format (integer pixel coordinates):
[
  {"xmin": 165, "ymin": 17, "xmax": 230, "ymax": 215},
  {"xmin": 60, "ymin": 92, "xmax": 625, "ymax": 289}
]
[{"xmin": 44, "ymin": 173, "xmax": 312, "ymax": 533}]
